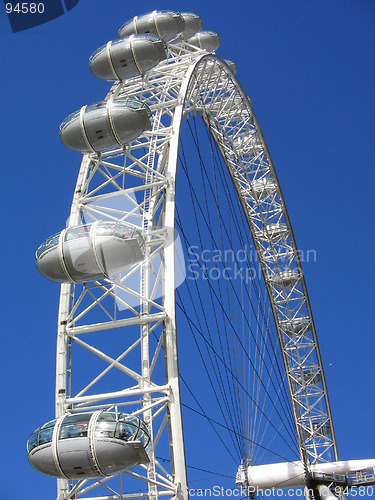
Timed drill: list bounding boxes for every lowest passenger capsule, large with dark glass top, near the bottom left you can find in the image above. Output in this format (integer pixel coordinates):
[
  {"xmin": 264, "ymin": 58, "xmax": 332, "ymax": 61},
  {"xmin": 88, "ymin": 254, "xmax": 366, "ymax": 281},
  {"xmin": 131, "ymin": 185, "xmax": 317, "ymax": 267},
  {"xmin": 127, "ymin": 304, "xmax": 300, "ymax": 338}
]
[{"xmin": 27, "ymin": 411, "xmax": 150, "ymax": 479}]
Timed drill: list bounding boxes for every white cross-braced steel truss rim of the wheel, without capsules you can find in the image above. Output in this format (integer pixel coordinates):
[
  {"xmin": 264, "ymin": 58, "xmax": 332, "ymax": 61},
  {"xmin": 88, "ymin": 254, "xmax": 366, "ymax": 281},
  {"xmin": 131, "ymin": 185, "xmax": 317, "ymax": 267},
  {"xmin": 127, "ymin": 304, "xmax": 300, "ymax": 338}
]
[{"xmin": 56, "ymin": 42, "xmax": 337, "ymax": 500}]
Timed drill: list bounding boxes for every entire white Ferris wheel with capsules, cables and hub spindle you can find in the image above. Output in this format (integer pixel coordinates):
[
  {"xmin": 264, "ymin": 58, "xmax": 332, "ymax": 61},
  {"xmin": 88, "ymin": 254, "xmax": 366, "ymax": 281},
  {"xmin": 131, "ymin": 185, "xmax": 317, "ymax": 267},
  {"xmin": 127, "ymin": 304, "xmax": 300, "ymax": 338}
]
[{"xmin": 27, "ymin": 7, "xmax": 375, "ymax": 500}]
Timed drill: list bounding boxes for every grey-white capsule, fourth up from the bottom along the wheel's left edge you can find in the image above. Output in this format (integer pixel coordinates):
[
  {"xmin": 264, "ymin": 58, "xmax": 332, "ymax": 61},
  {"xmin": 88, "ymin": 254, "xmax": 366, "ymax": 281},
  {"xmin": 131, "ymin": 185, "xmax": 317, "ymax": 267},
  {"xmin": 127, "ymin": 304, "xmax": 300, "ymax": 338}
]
[{"xmin": 89, "ymin": 34, "xmax": 167, "ymax": 80}]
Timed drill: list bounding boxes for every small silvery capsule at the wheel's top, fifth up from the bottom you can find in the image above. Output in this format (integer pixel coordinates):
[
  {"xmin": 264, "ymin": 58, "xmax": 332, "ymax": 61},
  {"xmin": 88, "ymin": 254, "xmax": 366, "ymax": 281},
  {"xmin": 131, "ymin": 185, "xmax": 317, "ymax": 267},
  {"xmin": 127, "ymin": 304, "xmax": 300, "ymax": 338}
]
[{"xmin": 118, "ymin": 10, "xmax": 184, "ymax": 42}]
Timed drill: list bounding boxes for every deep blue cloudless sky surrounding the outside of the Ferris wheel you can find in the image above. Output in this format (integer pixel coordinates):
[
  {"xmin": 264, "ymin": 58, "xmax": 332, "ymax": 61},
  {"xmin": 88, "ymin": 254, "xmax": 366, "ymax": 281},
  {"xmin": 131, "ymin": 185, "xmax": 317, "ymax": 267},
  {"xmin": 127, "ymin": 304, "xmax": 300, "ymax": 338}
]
[{"xmin": 0, "ymin": 0, "xmax": 375, "ymax": 500}]
